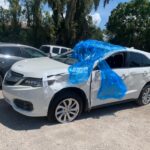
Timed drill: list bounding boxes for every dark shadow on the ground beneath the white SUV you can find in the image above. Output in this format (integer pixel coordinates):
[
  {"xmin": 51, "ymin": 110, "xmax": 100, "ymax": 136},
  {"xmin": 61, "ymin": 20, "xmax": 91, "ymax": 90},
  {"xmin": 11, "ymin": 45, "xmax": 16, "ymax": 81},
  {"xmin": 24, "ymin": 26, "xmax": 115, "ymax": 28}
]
[{"xmin": 0, "ymin": 99, "xmax": 137, "ymax": 130}]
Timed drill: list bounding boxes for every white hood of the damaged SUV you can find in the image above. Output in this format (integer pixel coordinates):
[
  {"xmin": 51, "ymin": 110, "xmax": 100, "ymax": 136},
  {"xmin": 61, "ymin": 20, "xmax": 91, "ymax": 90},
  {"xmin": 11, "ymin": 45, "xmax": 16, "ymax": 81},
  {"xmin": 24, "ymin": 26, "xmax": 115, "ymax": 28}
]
[{"xmin": 11, "ymin": 57, "xmax": 69, "ymax": 78}]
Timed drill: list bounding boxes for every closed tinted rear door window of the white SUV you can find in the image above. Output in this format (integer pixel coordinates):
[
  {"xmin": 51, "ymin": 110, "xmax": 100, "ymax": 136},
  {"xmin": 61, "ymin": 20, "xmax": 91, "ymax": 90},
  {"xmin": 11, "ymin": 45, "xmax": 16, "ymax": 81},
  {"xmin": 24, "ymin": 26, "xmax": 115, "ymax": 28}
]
[{"xmin": 127, "ymin": 52, "xmax": 150, "ymax": 68}]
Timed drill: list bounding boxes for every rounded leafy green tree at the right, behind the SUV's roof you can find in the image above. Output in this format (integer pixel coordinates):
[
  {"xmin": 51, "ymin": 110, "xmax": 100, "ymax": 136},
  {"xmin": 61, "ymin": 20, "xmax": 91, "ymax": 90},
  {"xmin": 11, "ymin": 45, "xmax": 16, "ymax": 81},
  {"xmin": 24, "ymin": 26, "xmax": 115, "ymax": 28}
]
[{"xmin": 107, "ymin": 0, "xmax": 150, "ymax": 51}]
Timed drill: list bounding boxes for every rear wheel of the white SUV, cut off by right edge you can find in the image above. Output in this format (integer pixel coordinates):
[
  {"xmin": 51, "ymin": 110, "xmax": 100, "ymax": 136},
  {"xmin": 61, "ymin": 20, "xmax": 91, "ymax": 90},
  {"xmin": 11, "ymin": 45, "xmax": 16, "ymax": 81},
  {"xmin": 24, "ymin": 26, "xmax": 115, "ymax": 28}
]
[{"xmin": 137, "ymin": 84, "xmax": 150, "ymax": 106}]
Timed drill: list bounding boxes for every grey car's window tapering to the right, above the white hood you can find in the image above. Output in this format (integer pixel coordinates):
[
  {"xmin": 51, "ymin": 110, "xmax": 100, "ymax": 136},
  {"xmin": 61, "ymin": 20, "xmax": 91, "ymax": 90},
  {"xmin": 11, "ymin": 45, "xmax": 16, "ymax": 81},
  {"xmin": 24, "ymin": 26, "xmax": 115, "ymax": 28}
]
[{"xmin": 22, "ymin": 47, "xmax": 46, "ymax": 58}]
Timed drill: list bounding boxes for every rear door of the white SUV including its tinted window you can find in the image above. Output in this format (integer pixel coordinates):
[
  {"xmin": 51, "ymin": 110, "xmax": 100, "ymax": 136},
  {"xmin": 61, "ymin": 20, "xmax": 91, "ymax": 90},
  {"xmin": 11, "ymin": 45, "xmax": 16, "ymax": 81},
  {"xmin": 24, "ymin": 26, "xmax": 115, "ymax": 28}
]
[{"xmin": 127, "ymin": 52, "xmax": 150, "ymax": 98}]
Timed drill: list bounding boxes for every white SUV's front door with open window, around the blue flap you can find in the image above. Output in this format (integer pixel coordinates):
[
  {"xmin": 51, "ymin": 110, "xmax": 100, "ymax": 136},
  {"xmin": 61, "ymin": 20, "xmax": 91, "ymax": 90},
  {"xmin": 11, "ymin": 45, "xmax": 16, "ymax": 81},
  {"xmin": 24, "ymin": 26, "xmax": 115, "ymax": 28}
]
[{"xmin": 91, "ymin": 52, "xmax": 131, "ymax": 107}]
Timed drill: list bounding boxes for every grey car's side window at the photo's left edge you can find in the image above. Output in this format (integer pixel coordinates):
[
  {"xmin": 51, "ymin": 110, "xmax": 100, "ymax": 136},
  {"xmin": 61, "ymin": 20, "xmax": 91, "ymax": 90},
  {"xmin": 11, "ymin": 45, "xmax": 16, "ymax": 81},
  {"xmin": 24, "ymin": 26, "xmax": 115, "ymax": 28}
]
[{"xmin": 0, "ymin": 46, "xmax": 21, "ymax": 57}]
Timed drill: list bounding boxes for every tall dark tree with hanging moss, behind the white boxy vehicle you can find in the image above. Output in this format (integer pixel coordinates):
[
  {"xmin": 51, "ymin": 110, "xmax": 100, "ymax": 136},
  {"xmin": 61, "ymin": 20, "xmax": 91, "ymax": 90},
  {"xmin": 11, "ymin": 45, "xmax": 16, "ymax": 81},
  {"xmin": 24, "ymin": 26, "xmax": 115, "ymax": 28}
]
[{"xmin": 48, "ymin": 0, "xmax": 109, "ymax": 46}]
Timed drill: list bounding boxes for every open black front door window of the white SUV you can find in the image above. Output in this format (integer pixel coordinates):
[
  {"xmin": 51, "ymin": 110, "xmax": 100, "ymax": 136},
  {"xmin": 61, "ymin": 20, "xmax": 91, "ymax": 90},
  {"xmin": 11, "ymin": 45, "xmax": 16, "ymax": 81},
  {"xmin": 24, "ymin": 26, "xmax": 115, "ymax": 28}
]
[{"xmin": 106, "ymin": 53, "xmax": 126, "ymax": 69}]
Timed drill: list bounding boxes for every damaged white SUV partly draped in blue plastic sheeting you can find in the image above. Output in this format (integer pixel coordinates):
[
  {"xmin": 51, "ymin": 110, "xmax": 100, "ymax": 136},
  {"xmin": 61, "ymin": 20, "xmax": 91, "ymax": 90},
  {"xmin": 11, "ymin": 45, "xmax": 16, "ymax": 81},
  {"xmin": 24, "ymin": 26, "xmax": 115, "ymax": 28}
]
[{"xmin": 3, "ymin": 48, "xmax": 150, "ymax": 123}]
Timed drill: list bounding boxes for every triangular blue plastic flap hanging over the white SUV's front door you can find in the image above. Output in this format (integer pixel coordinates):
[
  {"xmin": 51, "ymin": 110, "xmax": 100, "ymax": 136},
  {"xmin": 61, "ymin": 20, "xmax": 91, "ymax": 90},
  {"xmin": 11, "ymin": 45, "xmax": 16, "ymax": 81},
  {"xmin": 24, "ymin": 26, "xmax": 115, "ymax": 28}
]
[{"xmin": 97, "ymin": 61, "xmax": 127, "ymax": 99}]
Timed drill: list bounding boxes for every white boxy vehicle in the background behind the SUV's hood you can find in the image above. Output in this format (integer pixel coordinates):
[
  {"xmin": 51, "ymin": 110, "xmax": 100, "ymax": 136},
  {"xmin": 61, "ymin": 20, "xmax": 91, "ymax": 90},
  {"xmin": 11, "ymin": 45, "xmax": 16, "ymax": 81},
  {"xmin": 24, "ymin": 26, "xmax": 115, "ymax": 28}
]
[{"xmin": 40, "ymin": 45, "xmax": 71, "ymax": 57}]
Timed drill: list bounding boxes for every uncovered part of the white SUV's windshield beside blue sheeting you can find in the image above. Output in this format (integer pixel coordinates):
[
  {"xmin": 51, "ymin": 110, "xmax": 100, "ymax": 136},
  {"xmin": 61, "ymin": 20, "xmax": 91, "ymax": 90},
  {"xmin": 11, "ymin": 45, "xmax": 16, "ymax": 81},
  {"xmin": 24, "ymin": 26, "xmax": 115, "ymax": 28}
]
[{"xmin": 52, "ymin": 52, "xmax": 77, "ymax": 65}]
